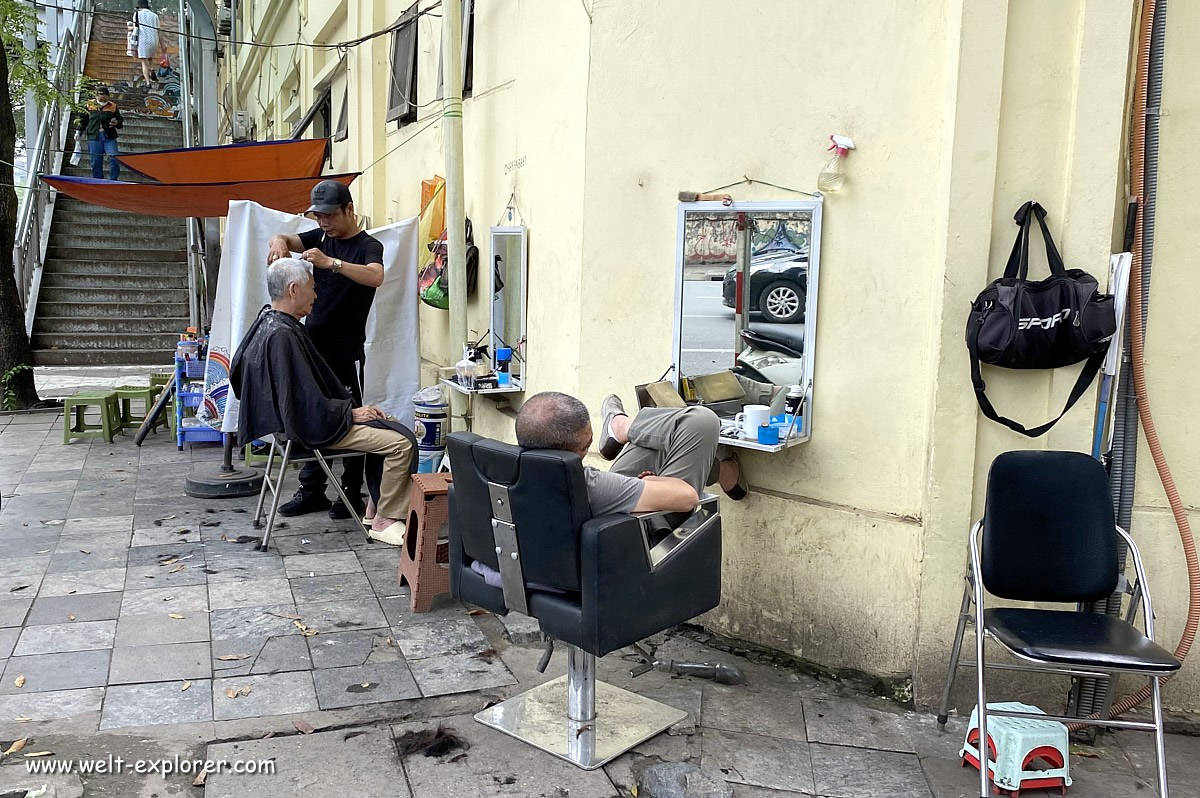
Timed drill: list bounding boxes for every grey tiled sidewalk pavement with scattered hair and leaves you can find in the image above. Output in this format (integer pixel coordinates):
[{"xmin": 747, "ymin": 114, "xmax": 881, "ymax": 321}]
[{"xmin": 0, "ymin": 414, "xmax": 1200, "ymax": 798}]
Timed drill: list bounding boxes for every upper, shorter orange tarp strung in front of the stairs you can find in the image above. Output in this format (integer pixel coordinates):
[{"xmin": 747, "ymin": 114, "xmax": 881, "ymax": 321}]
[{"xmin": 116, "ymin": 138, "xmax": 328, "ymax": 184}]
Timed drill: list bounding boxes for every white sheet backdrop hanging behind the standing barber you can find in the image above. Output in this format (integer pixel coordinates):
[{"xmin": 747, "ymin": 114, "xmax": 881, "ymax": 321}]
[{"xmin": 200, "ymin": 200, "xmax": 421, "ymax": 432}]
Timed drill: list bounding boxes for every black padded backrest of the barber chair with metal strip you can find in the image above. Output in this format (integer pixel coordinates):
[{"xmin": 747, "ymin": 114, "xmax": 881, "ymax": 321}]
[{"xmin": 446, "ymin": 432, "xmax": 592, "ymax": 592}]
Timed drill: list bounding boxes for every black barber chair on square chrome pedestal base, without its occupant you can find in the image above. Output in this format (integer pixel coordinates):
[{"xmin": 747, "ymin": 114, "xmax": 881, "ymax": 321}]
[{"xmin": 448, "ymin": 432, "xmax": 721, "ymax": 770}]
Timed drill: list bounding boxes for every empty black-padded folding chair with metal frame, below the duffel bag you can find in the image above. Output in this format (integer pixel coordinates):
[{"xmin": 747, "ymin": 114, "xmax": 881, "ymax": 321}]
[{"xmin": 937, "ymin": 451, "xmax": 1180, "ymax": 798}]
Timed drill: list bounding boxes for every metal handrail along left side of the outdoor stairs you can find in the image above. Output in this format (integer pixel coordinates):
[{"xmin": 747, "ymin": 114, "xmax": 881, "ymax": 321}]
[{"xmin": 12, "ymin": 0, "xmax": 94, "ymax": 335}]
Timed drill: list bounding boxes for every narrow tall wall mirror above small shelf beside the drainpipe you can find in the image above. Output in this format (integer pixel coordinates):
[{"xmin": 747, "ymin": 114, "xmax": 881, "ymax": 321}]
[{"xmin": 488, "ymin": 226, "xmax": 529, "ymax": 390}]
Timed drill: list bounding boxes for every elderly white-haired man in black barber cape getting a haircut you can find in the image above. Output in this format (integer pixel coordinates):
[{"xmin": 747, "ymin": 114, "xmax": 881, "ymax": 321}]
[{"xmin": 229, "ymin": 258, "xmax": 416, "ymax": 545}]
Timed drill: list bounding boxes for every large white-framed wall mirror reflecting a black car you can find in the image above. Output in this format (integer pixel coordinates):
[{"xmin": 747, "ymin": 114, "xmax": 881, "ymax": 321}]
[{"xmin": 674, "ymin": 198, "xmax": 822, "ymax": 451}]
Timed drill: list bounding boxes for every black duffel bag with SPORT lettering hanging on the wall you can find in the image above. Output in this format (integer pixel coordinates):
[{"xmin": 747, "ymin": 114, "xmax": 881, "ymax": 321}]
[{"xmin": 967, "ymin": 202, "xmax": 1117, "ymax": 438}]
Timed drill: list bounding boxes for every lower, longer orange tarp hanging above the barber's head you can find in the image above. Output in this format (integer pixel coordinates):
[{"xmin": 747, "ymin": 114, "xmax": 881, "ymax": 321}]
[{"xmin": 42, "ymin": 172, "xmax": 361, "ymax": 217}]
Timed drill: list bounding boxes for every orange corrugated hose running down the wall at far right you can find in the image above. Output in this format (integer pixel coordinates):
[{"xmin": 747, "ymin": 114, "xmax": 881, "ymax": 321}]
[{"xmin": 1072, "ymin": 0, "xmax": 1200, "ymax": 730}]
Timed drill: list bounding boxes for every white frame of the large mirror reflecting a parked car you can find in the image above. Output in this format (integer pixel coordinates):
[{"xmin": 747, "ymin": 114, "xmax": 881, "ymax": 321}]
[{"xmin": 671, "ymin": 194, "xmax": 823, "ymax": 451}]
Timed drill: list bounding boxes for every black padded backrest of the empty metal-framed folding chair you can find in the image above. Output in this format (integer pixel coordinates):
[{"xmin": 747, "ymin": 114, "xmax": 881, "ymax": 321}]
[{"xmin": 979, "ymin": 451, "xmax": 1118, "ymax": 601}]
